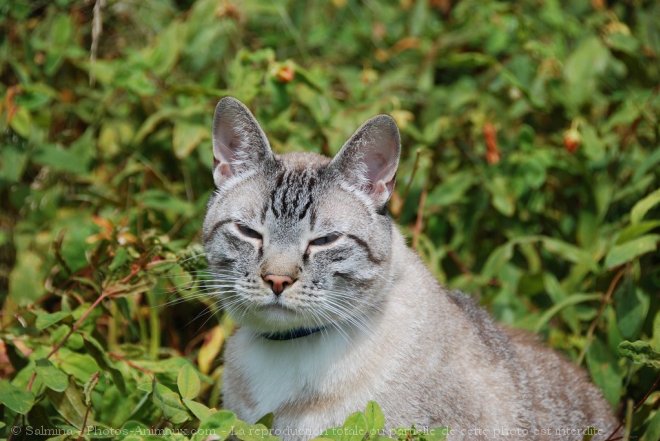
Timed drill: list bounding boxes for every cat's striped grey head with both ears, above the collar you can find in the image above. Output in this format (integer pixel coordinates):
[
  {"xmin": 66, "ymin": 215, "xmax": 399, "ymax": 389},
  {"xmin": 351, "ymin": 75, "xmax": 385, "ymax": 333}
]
[{"xmin": 203, "ymin": 98, "xmax": 400, "ymax": 333}]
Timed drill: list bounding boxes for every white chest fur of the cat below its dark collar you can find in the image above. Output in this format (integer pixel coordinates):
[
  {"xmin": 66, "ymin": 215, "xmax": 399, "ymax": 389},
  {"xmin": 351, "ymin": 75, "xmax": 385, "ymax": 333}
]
[{"xmin": 225, "ymin": 329, "xmax": 374, "ymax": 428}]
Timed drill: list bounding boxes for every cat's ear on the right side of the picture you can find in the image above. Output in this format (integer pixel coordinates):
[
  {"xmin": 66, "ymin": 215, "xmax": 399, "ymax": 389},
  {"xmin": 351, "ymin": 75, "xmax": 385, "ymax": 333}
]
[{"xmin": 332, "ymin": 115, "xmax": 401, "ymax": 209}]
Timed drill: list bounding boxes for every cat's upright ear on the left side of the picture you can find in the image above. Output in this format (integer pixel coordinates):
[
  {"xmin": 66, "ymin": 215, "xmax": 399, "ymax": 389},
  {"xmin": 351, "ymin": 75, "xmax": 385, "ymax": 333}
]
[{"xmin": 213, "ymin": 97, "xmax": 274, "ymax": 188}]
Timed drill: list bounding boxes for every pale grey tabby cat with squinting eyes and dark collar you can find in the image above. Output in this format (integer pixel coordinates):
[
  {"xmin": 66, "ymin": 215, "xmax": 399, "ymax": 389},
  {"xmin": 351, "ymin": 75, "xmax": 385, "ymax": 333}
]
[{"xmin": 202, "ymin": 97, "xmax": 617, "ymax": 441}]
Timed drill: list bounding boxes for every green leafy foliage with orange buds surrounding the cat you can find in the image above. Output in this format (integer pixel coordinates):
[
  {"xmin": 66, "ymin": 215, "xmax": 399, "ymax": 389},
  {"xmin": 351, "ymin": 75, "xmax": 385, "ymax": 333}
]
[{"xmin": 0, "ymin": 0, "xmax": 660, "ymax": 441}]
